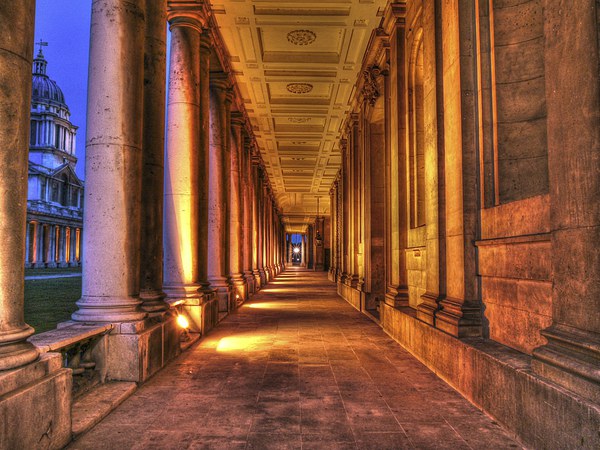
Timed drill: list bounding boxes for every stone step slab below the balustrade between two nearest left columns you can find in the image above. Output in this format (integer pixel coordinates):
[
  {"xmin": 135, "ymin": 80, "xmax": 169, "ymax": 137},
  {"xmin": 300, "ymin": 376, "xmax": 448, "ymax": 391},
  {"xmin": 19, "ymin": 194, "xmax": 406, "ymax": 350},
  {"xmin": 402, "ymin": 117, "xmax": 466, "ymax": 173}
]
[{"xmin": 71, "ymin": 381, "xmax": 137, "ymax": 439}]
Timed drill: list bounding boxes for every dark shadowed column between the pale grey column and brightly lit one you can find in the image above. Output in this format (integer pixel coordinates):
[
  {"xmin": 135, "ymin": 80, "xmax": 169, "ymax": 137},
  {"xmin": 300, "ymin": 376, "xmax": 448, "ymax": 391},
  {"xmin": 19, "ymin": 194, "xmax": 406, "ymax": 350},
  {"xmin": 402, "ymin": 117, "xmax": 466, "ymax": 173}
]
[{"xmin": 139, "ymin": 0, "xmax": 168, "ymax": 312}]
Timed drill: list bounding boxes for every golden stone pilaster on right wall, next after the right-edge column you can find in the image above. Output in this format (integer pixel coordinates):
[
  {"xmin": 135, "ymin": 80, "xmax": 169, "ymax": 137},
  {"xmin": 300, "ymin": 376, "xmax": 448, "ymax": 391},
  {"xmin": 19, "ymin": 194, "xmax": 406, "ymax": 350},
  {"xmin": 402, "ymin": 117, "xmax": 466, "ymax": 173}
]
[{"xmin": 435, "ymin": 0, "xmax": 482, "ymax": 337}]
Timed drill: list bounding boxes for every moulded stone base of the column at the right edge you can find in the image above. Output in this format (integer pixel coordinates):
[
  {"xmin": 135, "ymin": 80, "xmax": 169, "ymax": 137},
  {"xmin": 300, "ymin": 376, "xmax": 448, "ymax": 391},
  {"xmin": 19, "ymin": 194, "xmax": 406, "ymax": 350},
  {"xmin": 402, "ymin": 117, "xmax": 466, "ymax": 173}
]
[{"xmin": 531, "ymin": 324, "xmax": 600, "ymax": 403}]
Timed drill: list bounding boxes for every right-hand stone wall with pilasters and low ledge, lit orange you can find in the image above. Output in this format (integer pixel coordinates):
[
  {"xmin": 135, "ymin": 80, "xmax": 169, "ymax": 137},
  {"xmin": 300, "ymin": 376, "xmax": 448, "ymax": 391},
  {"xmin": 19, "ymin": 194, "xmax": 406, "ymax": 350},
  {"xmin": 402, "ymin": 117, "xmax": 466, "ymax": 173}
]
[{"xmin": 329, "ymin": 0, "xmax": 600, "ymax": 447}]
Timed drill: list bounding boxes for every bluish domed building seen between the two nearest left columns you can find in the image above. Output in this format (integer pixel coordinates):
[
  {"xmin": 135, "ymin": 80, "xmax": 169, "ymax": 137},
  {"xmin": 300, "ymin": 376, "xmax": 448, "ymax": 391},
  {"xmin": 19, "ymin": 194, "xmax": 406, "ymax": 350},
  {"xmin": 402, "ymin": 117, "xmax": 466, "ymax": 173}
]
[{"xmin": 25, "ymin": 45, "xmax": 83, "ymax": 268}]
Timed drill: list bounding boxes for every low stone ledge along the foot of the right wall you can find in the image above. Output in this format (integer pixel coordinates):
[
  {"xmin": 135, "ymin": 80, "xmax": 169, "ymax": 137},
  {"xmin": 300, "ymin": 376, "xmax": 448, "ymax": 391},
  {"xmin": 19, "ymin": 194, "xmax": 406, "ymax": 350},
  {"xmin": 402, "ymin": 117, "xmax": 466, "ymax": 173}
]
[{"xmin": 380, "ymin": 303, "xmax": 600, "ymax": 449}]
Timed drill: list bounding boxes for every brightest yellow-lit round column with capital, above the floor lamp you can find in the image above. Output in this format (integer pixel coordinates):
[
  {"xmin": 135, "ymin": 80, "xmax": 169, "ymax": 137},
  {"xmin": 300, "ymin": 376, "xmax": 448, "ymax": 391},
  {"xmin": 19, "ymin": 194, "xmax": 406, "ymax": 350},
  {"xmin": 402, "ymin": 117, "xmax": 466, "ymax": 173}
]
[{"xmin": 163, "ymin": 9, "xmax": 203, "ymax": 299}]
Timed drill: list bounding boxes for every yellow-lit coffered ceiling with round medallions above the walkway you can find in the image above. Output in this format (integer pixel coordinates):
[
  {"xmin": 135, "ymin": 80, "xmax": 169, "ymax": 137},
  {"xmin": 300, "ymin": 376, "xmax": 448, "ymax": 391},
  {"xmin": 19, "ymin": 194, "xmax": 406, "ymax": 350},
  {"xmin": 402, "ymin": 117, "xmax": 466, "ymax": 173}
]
[{"xmin": 211, "ymin": 0, "xmax": 386, "ymax": 232}]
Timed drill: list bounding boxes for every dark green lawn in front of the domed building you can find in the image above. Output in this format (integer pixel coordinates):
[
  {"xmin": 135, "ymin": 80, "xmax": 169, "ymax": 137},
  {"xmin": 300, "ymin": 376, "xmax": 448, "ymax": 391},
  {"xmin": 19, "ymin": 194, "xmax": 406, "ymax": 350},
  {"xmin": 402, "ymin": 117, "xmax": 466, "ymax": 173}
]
[{"xmin": 25, "ymin": 274, "xmax": 81, "ymax": 333}]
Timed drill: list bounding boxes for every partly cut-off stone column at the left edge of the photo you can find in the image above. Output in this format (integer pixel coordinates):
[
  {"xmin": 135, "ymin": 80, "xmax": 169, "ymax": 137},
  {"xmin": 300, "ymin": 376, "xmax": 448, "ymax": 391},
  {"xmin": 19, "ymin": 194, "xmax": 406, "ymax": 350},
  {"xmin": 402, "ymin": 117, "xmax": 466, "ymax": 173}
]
[{"xmin": 0, "ymin": 0, "xmax": 38, "ymax": 370}]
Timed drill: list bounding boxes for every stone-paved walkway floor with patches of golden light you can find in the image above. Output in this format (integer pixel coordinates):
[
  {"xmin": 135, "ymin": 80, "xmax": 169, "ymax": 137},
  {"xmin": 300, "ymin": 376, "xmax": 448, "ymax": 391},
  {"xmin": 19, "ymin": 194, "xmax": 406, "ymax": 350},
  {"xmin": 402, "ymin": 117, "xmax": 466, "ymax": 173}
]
[{"xmin": 71, "ymin": 269, "xmax": 519, "ymax": 449}]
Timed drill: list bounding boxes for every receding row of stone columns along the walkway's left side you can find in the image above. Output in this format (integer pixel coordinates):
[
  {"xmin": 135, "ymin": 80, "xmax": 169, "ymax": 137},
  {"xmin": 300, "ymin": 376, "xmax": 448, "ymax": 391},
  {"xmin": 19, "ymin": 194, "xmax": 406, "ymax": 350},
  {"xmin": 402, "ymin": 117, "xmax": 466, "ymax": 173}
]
[{"xmin": 0, "ymin": 0, "xmax": 284, "ymax": 370}]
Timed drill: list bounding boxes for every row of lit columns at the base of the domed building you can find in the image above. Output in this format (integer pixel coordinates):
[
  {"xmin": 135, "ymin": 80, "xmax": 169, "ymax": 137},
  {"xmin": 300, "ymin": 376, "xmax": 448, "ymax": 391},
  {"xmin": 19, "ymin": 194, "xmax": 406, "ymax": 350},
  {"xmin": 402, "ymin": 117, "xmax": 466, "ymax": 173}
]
[{"xmin": 25, "ymin": 220, "xmax": 81, "ymax": 268}]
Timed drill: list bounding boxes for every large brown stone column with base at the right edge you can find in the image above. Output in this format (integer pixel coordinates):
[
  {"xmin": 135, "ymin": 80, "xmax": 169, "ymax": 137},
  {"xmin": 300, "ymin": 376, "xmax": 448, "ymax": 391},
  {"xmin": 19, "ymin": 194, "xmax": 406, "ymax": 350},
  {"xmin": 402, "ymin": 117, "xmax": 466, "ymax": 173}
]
[{"xmin": 532, "ymin": 0, "xmax": 600, "ymax": 403}]
